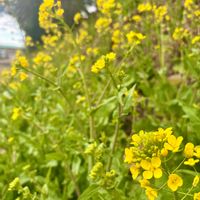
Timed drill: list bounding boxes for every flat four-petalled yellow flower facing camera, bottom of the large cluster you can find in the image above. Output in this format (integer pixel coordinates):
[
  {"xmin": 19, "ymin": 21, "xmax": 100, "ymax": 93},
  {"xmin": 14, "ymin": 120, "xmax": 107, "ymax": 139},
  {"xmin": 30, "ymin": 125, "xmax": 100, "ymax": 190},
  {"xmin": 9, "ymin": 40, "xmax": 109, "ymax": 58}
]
[{"xmin": 140, "ymin": 157, "xmax": 162, "ymax": 179}]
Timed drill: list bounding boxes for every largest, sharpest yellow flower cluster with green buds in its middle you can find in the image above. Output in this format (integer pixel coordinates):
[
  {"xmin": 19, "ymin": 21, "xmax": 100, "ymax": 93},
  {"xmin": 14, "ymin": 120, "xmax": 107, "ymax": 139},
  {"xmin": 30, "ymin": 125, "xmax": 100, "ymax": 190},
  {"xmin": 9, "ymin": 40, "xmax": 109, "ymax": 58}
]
[{"xmin": 125, "ymin": 128, "xmax": 183, "ymax": 179}]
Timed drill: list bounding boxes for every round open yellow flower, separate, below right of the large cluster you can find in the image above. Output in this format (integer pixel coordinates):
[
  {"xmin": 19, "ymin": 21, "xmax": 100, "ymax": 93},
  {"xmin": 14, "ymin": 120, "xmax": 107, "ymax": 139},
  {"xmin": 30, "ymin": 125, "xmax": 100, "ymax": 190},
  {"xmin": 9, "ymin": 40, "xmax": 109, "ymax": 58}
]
[{"xmin": 167, "ymin": 174, "xmax": 183, "ymax": 192}]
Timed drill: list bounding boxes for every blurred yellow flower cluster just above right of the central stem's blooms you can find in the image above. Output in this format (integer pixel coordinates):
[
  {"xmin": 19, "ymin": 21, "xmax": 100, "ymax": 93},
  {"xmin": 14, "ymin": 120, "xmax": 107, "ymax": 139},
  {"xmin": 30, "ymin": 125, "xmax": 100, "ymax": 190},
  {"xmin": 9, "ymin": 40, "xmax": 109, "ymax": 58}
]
[{"xmin": 126, "ymin": 31, "xmax": 146, "ymax": 46}]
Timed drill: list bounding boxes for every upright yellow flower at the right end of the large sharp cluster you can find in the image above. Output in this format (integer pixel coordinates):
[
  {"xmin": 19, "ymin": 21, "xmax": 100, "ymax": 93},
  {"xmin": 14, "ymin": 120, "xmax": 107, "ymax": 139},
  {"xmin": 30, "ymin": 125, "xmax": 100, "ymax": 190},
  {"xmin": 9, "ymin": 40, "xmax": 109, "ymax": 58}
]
[{"xmin": 164, "ymin": 135, "xmax": 183, "ymax": 152}]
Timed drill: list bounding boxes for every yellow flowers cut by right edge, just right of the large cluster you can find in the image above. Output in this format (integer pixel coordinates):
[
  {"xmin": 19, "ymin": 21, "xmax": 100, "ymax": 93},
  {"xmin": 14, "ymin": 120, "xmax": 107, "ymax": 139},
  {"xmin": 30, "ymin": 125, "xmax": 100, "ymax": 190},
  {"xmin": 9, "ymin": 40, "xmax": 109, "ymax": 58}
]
[{"xmin": 184, "ymin": 142, "xmax": 200, "ymax": 167}]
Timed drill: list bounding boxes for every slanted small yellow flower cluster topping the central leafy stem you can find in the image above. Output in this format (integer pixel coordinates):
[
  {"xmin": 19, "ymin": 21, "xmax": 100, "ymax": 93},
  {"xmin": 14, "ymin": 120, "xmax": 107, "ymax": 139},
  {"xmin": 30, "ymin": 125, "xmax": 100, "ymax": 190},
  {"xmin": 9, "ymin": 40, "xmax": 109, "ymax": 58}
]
[{"xmin": 91, "ymin": 52, "xmax": 116, "ymax": 73}]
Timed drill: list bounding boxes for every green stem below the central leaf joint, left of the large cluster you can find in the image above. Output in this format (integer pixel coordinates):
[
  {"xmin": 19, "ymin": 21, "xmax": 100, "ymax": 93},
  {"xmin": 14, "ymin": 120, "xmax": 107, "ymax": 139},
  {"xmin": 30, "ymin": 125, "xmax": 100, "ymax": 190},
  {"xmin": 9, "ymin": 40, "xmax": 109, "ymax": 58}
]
[{"xmin": 107, "ymin": 104, "xmax": 122, "ymax": 171}]
